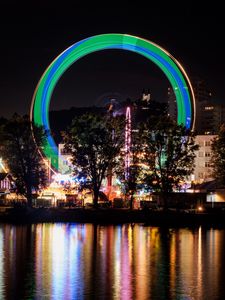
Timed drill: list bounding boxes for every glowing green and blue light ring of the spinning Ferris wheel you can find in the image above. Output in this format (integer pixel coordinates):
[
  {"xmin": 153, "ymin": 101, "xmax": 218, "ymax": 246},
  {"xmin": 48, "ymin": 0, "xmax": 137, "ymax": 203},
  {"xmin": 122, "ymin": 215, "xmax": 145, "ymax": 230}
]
[{"xmin": 30, "ymin": 34, "xmax": 195, "ymax": 169}]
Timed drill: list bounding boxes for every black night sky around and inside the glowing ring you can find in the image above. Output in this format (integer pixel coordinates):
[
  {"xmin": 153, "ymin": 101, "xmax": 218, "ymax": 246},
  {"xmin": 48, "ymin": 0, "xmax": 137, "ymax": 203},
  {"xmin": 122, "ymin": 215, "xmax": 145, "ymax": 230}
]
[{"xmin": 0, "ymin": 0, "xmax": 225, "ymax": 117}]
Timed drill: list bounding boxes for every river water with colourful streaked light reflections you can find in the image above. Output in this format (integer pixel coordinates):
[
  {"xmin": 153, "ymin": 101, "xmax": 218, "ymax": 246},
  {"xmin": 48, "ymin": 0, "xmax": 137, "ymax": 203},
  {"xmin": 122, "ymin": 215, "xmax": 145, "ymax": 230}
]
[{"xmin": 0, "ymin": 224, "xmax": 225, "ymax": 300}]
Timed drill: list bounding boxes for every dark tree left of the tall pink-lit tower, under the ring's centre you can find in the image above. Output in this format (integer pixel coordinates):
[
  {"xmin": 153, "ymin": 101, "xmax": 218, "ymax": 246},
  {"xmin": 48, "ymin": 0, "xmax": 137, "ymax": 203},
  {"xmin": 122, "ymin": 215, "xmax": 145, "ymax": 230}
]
[{"xmin": 64, "ymin": 113, "xmax": 124, "ymax": 207}]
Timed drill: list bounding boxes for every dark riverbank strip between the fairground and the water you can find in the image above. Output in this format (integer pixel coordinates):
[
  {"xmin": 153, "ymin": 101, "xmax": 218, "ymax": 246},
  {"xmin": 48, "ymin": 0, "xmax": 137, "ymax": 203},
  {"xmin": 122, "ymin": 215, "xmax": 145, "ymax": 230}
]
[{"xmin": 0, "ymin": 208, "xmax": 225, "ymax": 227}]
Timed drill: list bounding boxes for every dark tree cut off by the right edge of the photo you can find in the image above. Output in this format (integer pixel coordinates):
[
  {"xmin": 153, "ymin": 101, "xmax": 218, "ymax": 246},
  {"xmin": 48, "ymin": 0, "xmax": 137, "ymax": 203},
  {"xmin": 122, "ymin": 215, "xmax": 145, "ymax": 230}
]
[{"xmin": 211, "ymin": 125, "xmax": 225, "ymax": 184}]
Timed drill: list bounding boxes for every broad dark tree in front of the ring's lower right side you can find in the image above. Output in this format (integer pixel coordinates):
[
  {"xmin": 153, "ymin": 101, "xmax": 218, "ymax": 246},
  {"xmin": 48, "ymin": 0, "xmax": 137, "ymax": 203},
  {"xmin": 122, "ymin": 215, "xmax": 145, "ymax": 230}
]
[{"xmin": 141, "ymin": 117, "xmax": 198, "ymax": 206}]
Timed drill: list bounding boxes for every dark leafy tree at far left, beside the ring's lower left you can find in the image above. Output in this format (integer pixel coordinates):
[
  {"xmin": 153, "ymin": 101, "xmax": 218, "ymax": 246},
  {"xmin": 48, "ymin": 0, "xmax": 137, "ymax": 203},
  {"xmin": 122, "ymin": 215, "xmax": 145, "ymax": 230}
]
[{"xmin": 0, "ymin": 114, "xmax": 47, "ymax": 206}]
